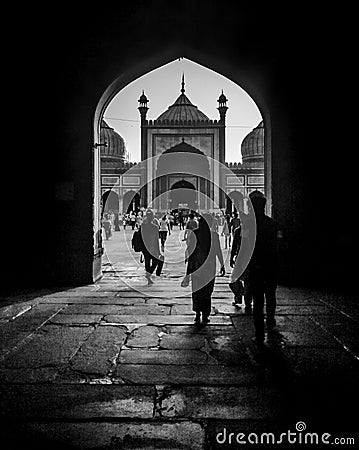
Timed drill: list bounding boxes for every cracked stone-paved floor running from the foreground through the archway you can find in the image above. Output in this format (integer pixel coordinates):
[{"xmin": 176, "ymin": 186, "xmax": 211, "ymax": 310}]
[{"xmin": 0, "ymin": 232, "xmax": 359, "ymax": 450}]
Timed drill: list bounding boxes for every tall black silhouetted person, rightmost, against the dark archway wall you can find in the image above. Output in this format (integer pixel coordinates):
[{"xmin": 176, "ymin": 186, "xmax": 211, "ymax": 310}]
[{"xmin": 248, "ymin": 191, "xmax": 278, "ymax": 344}]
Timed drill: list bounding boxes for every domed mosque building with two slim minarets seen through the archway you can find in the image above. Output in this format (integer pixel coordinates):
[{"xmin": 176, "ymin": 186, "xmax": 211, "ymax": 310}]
[{"xmin": 101, "ymin": 76, "xmax": 264, "ymax": 214}]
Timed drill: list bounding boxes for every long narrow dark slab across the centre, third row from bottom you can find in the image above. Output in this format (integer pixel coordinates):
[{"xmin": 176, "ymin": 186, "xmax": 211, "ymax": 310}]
[{"xmin": 113, "ymin": 364, "xmax": 258, "ymax": 386}]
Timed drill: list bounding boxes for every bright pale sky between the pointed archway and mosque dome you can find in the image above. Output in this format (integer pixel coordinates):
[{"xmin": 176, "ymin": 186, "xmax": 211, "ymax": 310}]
[{"xmin": 104, "ymin": 59, "xmax": 262, "ymax": 162}]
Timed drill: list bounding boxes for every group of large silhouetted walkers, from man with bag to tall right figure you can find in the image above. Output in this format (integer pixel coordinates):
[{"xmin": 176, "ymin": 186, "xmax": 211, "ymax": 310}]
[{"xmin": 135, "ymin": 191, "xmax": 279, "ymax": 344}]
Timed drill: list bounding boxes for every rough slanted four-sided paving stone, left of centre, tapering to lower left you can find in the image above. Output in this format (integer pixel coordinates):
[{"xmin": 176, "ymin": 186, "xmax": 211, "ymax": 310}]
[{"xmin": 70, "ymin": 326, "xmax": 127, "ymax": 376}]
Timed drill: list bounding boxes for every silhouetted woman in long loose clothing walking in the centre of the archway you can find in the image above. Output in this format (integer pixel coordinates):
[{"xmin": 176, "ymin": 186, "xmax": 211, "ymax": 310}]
[{"xmin": 186, "ymin": 214, "xmax": 225, "ymax": 324}]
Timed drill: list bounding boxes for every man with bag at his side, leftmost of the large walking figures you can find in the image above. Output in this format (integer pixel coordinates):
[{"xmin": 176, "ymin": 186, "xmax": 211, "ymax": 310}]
[{"xmin": 140, "ymin": 209, "xmax": 163, "ymax": 284}]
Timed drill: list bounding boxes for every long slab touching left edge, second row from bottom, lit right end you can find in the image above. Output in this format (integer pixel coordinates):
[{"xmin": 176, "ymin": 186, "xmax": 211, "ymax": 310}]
[{"xmin": 0, "ymin": 384, "xmax": 155, "ymax": 420}]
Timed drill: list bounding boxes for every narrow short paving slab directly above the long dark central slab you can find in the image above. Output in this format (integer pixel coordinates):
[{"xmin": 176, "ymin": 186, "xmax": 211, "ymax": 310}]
[{"xmin": 119, "ymin": 349, "xmax": 215, "ymax": 365}]
